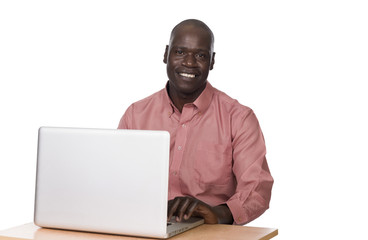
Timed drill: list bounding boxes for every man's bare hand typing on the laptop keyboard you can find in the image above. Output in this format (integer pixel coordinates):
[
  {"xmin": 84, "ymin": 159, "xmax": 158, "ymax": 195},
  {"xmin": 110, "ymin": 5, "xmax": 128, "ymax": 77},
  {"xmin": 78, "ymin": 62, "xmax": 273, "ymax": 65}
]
[{"xmin": 167, "ymin": 197, "xmax": 233, "ymax": 224}]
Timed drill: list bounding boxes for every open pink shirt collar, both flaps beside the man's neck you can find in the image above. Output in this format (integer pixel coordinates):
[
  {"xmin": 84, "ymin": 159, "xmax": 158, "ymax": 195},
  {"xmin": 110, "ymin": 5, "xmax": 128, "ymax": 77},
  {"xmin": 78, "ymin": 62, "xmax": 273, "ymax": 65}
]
[{"xmin": 165, "ymin": 81, "xmax": 214, "ymax": 114}]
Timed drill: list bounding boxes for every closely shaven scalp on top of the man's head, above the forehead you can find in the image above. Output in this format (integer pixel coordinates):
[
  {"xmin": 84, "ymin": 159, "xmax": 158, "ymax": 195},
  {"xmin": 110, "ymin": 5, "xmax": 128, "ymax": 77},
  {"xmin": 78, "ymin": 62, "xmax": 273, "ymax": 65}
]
[{"xmin": 169, "ymin": 19, "xmax": 215, "ymax": 52}]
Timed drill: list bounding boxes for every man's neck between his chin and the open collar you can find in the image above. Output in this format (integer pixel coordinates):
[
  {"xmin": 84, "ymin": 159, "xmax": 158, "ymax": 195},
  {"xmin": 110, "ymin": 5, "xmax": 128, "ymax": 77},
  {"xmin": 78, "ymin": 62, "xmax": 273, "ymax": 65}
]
[{"xmin": 167, "ymin": 82, "xmax": 207, "ymax": 113}]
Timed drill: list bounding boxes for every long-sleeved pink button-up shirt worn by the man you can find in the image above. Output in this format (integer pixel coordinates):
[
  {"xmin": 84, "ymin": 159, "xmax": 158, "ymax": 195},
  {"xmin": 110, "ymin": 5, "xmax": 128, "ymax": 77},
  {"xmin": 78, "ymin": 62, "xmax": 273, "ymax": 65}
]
[{"xmin": 118, "ymin": 83, "xmax": 273, "ymax": 224}]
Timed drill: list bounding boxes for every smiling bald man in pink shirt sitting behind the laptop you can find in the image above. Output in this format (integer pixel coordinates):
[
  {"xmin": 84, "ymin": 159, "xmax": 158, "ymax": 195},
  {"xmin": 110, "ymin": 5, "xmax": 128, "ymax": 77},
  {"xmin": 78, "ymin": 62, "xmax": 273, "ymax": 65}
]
[{"xmin": 119, "ymin": 19, "xmax": 273, "ymax": 224}]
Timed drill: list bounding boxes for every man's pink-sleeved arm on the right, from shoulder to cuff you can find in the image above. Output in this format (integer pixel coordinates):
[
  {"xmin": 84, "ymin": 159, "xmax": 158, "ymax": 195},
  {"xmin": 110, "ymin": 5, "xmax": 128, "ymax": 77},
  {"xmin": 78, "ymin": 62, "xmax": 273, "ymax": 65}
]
[{"xmin": 226, "ymin": 110, "xmax": 273, "ymax": 224}]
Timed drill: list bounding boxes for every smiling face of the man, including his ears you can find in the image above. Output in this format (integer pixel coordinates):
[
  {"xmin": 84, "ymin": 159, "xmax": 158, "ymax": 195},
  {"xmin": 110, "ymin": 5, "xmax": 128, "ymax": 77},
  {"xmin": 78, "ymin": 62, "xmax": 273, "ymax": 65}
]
[{"xmin": 164, "ymin": 26, "xmax": 214, "ymax": 96}]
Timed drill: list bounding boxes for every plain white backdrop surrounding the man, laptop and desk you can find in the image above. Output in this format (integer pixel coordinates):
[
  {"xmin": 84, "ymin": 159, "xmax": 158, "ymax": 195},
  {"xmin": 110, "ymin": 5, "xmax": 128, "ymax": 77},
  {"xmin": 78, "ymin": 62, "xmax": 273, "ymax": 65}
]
[{"xmin": 0, "ymin": 0, "xmax": 368, "ymax": 239}]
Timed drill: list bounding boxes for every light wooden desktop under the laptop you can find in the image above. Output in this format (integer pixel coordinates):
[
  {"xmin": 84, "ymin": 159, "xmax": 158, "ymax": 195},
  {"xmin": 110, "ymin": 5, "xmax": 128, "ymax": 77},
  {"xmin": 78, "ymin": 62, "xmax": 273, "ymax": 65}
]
[{"xmin": 0, "ymin": 223, "xmax": 278, "ymax": 240}]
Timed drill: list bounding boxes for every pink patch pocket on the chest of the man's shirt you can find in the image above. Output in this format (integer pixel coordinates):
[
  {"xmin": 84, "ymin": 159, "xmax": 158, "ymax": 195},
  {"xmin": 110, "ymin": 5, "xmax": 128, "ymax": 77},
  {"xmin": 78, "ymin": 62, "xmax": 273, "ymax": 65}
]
[{"xmin": 194, "ymin": 141, "xmax": 233, "ymax": 185}]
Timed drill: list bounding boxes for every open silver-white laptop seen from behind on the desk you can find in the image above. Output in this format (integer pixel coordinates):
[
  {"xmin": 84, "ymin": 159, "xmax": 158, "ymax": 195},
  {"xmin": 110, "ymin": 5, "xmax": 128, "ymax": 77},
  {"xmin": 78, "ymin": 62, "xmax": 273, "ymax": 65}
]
[{"xmin": 34, "ymin": 127, "xmax": 203, "ymax": 238}]
